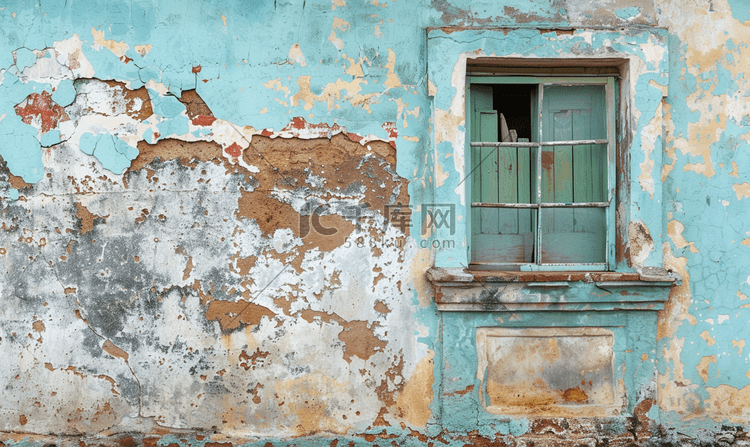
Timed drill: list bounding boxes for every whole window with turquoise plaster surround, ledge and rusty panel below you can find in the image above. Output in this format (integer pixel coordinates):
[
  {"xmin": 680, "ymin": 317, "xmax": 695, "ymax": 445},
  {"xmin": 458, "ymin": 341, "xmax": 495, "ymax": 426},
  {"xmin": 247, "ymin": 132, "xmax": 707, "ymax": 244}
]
[{"xmin": 425, "ymin": 27, "xmax": 679, "ymax": 431}]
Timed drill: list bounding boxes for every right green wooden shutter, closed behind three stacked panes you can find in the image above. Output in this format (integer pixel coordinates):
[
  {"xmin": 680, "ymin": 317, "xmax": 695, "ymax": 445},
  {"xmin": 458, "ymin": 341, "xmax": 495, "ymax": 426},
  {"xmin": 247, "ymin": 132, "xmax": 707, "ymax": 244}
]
[{"xmin": 541, "ymin": 85, "xmax": 607, "ymax": 263}]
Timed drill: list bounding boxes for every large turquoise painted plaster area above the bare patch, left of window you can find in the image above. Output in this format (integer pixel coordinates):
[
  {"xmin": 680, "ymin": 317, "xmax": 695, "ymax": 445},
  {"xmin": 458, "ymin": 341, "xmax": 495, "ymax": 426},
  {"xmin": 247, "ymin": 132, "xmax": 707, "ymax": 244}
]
[{"xmin": 0, "ymin": 2, "xmax": 434, "ymax": 189}]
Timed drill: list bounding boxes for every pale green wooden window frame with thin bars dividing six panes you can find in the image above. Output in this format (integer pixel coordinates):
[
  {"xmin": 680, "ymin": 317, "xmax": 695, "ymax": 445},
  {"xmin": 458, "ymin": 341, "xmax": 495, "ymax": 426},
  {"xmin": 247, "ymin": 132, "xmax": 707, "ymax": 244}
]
[{"xmin": 465, "ymin": 73, "xmax": 618, "ymax": 271}]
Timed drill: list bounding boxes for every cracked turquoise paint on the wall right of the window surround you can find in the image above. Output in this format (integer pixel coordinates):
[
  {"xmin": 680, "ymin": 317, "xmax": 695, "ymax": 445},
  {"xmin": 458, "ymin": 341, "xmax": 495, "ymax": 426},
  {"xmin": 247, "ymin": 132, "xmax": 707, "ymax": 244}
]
[{"xmin": 659, "ymin": 28, "xmax": 750, "ymax": 436}]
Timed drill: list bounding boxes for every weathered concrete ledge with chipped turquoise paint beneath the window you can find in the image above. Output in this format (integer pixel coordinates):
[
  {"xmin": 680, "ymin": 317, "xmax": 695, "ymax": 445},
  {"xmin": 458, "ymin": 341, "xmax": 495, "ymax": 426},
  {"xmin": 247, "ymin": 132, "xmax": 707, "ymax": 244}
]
[{"xmin": 427, "ymin": 267, "xmax": 682, "ymax": 312}]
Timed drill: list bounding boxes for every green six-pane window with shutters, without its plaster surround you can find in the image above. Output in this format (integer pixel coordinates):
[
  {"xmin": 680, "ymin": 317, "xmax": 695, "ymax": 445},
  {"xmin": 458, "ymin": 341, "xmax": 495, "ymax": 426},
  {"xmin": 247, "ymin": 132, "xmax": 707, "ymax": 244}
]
[{"xmin": 466, "ymin": 75, "xmax": 616, "ymax": 270}]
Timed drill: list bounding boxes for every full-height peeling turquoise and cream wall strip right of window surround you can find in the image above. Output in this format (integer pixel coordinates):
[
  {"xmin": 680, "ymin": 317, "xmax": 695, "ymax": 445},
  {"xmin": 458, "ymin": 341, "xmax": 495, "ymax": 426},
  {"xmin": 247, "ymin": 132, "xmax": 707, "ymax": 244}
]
[{"xmin": 658, "ymin": 1, "xmax": 750, "ymax": 434}]
